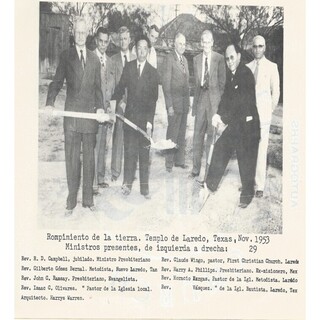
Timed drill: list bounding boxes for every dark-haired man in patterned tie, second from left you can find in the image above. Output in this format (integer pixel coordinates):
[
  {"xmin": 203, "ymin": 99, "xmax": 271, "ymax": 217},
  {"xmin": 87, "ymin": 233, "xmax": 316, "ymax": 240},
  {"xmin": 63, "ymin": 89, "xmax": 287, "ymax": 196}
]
[{"xmin": 94, "ymin": 27, "xmax": 112, "ymax": 193}]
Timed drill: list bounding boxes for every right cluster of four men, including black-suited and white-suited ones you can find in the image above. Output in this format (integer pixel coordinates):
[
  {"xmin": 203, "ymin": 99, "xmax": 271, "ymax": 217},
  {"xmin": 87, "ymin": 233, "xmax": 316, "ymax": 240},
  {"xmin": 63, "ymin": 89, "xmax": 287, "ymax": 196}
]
[{"xmin": 162, "ymin": 30, "xmax": 280, "ymax": 208}]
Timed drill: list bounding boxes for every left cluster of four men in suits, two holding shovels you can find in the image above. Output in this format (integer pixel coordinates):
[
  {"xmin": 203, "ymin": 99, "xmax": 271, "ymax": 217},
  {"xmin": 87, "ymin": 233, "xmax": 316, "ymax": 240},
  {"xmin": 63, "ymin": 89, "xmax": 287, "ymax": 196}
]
[{"xmin": 46, "ymin": 18, "xmax": 159, "ymax": 215}]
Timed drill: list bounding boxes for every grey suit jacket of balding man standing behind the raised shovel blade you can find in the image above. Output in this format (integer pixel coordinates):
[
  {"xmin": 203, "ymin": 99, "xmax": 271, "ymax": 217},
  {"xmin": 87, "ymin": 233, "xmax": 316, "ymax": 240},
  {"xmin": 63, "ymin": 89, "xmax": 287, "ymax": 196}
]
[{"xmin": 162, "ymin": 51, "xmax": 190, "ymax": 113}]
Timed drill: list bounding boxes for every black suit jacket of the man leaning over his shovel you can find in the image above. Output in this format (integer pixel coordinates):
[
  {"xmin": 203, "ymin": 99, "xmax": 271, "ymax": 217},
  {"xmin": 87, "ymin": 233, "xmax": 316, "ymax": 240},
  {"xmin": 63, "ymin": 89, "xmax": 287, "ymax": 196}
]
[{"xmin": 217, "ymin": 63, "xmax": 260, "ymax": 140}]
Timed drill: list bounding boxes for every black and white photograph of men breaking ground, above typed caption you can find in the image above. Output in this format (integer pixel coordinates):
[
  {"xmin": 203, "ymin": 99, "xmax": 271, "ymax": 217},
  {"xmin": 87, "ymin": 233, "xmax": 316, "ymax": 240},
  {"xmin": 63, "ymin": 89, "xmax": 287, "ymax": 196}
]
[{"xmin": 38, "ymin": 2, "xmax": 284, "ymax": 234}]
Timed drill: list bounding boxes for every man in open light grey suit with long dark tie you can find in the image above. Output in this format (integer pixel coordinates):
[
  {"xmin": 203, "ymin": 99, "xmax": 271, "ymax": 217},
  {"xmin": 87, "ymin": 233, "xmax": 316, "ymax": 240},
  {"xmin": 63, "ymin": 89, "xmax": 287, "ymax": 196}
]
[{"xmin": 190, "ymin": 30, "xmax": 226, "ymax": 178}]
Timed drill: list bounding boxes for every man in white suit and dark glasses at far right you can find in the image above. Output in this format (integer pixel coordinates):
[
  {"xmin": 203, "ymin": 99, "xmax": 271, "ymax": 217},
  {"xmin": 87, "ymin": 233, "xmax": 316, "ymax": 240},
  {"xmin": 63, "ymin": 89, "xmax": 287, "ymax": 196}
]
[{"xmin": 247, "ymin": 35, "xmax": 280, "ymax": 198}]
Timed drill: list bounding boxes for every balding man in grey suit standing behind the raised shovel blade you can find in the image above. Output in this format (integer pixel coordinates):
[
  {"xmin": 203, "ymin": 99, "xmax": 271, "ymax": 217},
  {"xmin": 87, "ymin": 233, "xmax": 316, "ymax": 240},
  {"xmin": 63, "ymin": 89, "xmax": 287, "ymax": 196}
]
[{"xmin": 162, "ymin": 33, "xmax": 190, "ymax": 172}]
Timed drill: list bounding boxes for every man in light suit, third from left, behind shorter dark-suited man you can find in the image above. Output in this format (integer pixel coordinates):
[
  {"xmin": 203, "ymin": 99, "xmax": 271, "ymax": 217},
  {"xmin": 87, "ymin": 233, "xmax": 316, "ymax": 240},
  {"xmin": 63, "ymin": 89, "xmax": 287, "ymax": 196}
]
[{"xmin": 111, "ymin": 26, "xmax": 136, "ymax": 181}]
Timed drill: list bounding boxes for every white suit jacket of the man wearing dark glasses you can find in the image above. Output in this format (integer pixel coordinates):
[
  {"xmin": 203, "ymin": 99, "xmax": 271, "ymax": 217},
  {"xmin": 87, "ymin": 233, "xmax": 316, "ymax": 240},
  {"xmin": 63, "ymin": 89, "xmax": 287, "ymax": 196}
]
[{"xmin": 247, "ymin": 57, "xmax": 280, "ymax": 123}]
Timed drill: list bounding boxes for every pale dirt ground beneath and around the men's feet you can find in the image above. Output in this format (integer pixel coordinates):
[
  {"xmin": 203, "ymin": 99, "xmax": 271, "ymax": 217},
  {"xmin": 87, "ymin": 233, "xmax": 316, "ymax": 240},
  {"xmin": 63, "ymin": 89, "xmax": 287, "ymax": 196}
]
[{"xmin": 38, "ymin": 80, "xmax": 282, "ymax": 234}]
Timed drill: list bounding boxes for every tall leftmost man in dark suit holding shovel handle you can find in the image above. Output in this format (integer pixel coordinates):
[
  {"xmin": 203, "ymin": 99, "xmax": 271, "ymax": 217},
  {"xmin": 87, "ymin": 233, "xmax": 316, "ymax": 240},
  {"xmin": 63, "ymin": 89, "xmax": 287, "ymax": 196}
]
[{"xmin": 46, "ymin": 18, "xmax": 103, "ymax": 215}]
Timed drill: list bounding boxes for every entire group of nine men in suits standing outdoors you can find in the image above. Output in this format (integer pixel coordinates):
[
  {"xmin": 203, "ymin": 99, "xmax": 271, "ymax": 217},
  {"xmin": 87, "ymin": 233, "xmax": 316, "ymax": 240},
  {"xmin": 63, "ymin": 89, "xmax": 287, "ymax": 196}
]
[{"xmin": 46, "ymin": 18, "xmax": 279, "ymax": 215}]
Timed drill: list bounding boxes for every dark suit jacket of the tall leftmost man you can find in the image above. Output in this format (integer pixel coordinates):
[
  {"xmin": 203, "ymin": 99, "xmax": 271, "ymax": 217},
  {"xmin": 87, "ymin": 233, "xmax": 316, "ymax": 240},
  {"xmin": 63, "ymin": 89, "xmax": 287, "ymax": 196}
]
[{"xmin": 46, "ymin": 47, "xmax": 103, "ymax": 133}]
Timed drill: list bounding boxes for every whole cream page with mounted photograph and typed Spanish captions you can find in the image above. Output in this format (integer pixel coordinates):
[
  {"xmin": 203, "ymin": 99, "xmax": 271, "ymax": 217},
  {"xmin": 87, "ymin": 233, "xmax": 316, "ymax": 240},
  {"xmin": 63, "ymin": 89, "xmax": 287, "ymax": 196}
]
[{"xmin": 14, "ymin": 0, "xmax": 306, "ymax": 320}]
